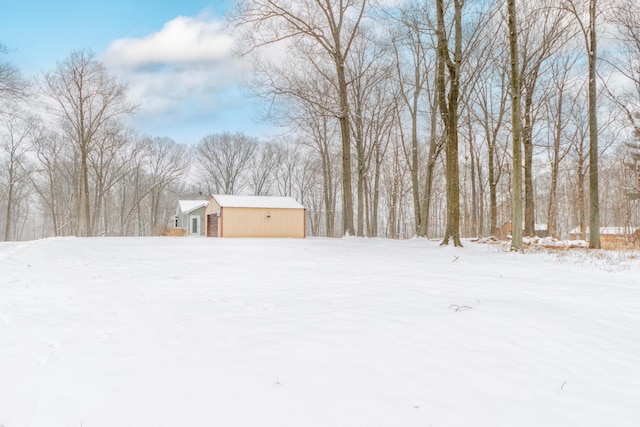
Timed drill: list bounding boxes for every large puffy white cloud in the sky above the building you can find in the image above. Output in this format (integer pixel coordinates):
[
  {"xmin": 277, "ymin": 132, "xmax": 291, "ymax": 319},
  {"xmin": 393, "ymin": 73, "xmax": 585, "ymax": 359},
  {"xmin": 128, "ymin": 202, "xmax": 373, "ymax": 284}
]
[{"xmin": 101, "ymin": 15, "xmax": 255, "ymax": 143}]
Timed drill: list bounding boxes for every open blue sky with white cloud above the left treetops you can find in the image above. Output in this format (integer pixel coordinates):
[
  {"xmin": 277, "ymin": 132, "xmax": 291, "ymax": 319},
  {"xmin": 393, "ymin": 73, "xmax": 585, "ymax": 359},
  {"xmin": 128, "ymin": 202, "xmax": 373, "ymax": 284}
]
[{"xmin": 0, "ymin": 0, "xmax": 269, "ymax": 144}]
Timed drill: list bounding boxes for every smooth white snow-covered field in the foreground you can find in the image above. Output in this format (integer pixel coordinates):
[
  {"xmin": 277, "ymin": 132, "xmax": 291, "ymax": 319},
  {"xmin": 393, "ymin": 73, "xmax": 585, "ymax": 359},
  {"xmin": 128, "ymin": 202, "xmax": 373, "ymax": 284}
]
[{"xmin": 0, "ymin": 237, "xmax": 640, "ymax": 427}]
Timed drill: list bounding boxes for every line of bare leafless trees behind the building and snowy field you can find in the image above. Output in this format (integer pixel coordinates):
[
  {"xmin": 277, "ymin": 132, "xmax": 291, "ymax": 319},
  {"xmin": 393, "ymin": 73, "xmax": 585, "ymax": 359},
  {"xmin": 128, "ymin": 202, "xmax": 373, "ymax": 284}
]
[{"xmin": 0, "ymin": 0, "xmax": 640, "ymax": 247}]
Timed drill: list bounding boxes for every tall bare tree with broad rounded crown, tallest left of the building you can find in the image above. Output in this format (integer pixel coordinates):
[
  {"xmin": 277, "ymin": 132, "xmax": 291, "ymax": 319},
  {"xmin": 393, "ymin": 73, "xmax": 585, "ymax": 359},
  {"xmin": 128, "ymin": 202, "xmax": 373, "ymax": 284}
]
[{"xmin": 42, "ymin": 50, "xmax": 135, "ymax": 236}]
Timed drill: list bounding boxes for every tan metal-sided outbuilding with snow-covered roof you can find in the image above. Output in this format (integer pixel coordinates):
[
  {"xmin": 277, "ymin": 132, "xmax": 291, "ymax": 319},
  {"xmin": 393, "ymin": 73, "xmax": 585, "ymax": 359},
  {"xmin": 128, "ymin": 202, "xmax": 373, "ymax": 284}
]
[{"xmin": 205, "ymin": 195, "xmax": 306, "ymax": 238}]
